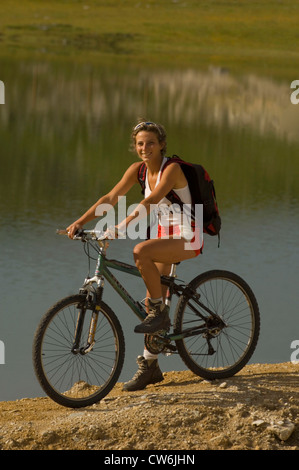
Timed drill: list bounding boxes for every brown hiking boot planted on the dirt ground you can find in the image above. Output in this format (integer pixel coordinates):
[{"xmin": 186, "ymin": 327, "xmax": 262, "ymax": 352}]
[{"xmin": 123, "ymin": 356, "xmax": 164, "ymax": 392}]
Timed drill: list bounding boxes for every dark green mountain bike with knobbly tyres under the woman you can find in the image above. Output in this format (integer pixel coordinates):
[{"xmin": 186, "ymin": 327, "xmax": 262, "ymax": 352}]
[{"xmin": 33, "ymin": 230, "xmax": 260, "ymax": 408}]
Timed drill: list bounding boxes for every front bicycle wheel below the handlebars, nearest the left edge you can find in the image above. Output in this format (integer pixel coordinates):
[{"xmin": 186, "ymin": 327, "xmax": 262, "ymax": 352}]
[{"xmin": 33, "ymin": 294, "xmax": 125, "ymax": 408}]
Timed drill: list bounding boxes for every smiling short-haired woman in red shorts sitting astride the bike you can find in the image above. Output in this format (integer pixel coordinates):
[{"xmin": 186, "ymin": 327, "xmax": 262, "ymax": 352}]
[{"xmin": 67, "ymin": 122, "xmax": 200, "ymax": 391}]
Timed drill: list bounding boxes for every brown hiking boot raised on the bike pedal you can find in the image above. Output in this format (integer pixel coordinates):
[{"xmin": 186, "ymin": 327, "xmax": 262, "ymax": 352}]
[{"xmin": 134, "ymin": 299, "xmax": 170, "ymax": 334}]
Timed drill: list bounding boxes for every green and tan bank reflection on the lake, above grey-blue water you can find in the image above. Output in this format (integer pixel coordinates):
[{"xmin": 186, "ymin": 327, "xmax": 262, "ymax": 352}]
[{"xmin": 0, "ymin": 62, "xmax": 299, "ymax": 226}]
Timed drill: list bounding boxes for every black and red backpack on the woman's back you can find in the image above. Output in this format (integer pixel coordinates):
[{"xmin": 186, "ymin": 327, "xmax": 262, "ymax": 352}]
[{"xmin": 138, "ymin": 155, "xmax": 221, "ymax": 238}]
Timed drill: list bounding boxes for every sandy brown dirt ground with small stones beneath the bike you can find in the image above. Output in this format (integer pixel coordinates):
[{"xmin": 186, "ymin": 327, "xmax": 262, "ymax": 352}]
[{"xmin": 0, "ymin": 363, "xmax": 299, "ymax": 451}]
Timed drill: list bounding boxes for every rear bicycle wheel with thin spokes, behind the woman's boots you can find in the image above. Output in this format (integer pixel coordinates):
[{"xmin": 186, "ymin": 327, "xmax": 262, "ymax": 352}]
[{"xmin": 174, "ymin": 270, "xmax": 260, "ymax": 380}]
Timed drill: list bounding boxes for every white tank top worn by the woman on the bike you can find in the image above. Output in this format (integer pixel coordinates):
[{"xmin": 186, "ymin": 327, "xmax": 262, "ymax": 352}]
[{"xmin": 144, "ymin": 157, "xmax": 192, "ymax": 229}]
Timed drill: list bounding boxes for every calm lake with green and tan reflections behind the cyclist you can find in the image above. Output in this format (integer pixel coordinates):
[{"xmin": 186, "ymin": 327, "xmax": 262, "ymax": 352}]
[{"xmin": 0, "ymin": 60, "xmax": 299, "ymax": 400}]
